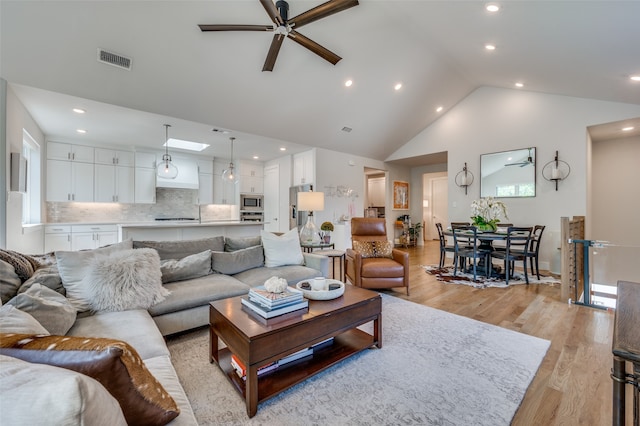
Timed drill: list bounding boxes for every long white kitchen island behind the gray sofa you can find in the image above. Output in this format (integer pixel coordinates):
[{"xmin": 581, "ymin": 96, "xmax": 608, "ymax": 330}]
[{"xmin": 118, "ymin": 220, "xmax": 264, "ymax": 241}]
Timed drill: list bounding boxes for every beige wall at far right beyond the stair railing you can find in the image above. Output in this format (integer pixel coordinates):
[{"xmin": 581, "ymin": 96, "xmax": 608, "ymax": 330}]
[{"xmin": 590, "ymin": 136, "xmax": 640, "ymax": 284}]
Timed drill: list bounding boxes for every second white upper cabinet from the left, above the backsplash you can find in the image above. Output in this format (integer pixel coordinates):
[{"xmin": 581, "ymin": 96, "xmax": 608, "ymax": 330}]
[{"xmin": 94, "ymin": 164, "xmax": 135, "ymax": 203}]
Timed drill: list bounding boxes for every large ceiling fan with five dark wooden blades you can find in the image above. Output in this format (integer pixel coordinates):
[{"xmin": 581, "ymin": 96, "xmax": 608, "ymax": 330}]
[{"xmin": 198, "ymin": 0, "xmax": 358, "ymax": 71}]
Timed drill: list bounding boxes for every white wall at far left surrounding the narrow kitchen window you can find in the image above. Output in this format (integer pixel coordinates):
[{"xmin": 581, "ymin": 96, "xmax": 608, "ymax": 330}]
[{"xmin": 6, "ymin": 87, "xmax": 45, "ymax": 254}]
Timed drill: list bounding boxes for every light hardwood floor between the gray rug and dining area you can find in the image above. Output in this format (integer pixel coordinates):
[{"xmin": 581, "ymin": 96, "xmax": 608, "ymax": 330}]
[{"xmin": 384, "ymin": 241, "xmax": 616, "ymax": 425}]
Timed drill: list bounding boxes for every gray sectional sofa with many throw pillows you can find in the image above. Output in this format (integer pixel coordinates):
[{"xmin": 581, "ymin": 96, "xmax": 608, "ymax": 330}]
[{"xmin": 0, "ymin": 234, "xmax": 329, "ymax": 425}]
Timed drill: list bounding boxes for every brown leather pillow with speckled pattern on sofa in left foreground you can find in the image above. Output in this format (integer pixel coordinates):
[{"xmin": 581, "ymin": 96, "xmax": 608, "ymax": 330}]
[{"xmin": 0, "ymin": 333, "xmax": 180, "ymax": 425}]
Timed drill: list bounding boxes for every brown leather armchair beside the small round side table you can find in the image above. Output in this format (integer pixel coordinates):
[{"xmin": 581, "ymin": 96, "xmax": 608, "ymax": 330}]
[{"xmin": 345, "ymin": 217, "xmax": 409, "ymax": 296}]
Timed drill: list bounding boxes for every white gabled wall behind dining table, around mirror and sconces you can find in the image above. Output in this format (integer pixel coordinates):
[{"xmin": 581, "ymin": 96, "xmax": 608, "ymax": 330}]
[{"xmin": 387, "ymin": 87, "xmax": 640, "ymax": 268}]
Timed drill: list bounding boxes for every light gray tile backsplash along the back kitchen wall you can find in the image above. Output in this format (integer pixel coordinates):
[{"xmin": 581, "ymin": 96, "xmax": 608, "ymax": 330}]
[{"xmin": 47, "ymin": 188, "xmax": 237, "ymax": 223}]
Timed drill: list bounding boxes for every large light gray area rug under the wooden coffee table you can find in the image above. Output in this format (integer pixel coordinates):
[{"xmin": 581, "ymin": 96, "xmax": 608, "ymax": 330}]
[{"xmin": 167, "ymin": 294, "xmax": 549, "ymax": 426}]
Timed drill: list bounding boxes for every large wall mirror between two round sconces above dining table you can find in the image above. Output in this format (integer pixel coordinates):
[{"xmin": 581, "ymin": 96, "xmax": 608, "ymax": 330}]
[{"xmin": 480, "ymin": 147, "xmax": 536, "ymax": 198}]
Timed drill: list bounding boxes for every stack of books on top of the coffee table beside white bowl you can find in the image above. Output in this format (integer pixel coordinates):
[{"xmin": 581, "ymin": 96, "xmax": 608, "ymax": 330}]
[{"xmin": 242, "ymin": 286, "xmax": 309, "ymax": 318}]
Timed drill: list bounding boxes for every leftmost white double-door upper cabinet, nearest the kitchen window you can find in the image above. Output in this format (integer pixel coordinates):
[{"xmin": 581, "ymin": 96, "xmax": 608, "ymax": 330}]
[{"xmin": 47, "ymin": 160, "xmax": 94, "ymax": 202}]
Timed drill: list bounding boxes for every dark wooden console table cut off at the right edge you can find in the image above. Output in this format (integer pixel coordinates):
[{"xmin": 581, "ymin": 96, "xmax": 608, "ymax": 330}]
[{"xmin": 611, "ymin": 281, "xmax": 640, "ymax": 426}]
